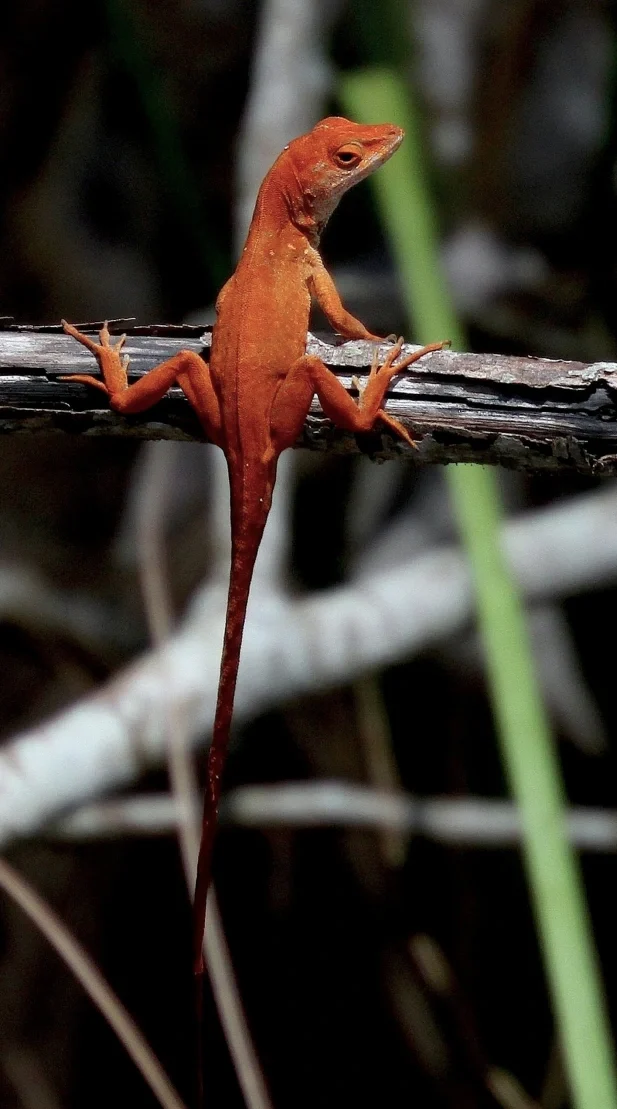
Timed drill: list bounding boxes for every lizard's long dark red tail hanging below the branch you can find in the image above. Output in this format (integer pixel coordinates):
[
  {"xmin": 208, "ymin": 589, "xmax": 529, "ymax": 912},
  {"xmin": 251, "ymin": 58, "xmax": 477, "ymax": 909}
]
[{"xmin": 193, "ymin": 495, "xmax": 270, "ymax": 977}]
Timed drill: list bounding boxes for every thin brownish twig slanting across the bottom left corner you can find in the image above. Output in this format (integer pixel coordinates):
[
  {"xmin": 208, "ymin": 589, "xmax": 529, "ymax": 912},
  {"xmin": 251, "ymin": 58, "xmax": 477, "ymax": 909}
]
[{"xmin": 0, "ymin": 858, "xmax": 185, "ymax": 1109}]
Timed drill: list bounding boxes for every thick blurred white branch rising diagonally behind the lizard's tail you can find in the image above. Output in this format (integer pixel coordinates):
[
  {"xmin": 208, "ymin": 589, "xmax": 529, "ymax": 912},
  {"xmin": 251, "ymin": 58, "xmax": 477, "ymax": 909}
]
[{"xmin": 0, "ymin": 488, "xmax": 617, "ymax": 843}]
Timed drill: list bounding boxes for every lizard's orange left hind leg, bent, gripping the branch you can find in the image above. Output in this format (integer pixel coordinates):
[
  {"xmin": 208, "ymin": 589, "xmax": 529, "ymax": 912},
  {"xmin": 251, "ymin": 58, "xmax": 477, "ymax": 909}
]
[{"xmin": 61, "ymin": 319, "xmax": 221, "ymax": 446}]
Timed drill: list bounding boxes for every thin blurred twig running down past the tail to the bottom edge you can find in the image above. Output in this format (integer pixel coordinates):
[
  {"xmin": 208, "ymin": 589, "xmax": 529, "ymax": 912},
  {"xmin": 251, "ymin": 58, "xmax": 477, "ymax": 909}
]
[{"xmin": 136, "ymin": 444, "xmax": 272, "ymax": 1109}]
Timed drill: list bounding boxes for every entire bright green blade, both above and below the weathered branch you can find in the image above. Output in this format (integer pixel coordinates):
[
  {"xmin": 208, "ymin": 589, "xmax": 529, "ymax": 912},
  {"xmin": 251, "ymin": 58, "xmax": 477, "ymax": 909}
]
[{"xmin": 340, "ymin": 68, "xmax": 617, "ymax": 1109}]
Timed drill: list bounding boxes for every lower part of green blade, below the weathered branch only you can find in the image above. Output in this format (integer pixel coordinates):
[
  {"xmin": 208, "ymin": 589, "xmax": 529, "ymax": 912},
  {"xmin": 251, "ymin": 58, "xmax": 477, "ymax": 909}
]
[{"xmin": 451, "ymin": 466, "xmax": 617, "ymax": 1109}]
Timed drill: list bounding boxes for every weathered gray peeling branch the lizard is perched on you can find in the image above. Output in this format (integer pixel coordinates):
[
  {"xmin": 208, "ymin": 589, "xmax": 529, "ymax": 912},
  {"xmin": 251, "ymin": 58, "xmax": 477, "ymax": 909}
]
[{"xmin": 0, "ymin": 322, "xmax": 617, "ymax": 474}]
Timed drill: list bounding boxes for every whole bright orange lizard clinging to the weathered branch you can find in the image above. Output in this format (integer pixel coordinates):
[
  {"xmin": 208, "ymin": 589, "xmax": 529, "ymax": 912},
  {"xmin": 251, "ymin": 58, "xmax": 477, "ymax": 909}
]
[{"xmin": 64, "ymin": 118, "xmax": 444, "ymax": 974}]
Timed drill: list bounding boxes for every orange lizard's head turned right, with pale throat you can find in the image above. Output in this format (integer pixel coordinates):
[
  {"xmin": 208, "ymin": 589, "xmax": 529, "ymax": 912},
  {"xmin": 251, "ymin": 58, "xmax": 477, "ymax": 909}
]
[{"xmin": 281, "ymin": 116, "xmax": 403, "ymax": 238}]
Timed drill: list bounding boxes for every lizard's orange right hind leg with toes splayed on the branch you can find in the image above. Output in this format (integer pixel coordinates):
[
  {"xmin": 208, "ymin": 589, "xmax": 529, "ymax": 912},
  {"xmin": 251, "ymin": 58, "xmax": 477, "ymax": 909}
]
[{"xmin": 271, "ymin": 339, "xmax": 447, "ymax": 454}]
